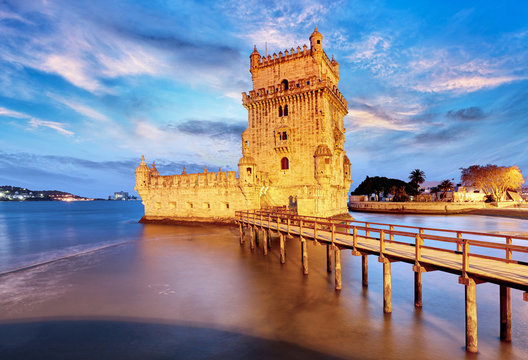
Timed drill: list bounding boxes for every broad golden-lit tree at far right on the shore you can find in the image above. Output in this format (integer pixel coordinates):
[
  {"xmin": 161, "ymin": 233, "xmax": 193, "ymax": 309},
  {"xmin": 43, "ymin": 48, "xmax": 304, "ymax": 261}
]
[{"xmin": 460, "ymin": 164, "xmax": 525, "ymax": 201}]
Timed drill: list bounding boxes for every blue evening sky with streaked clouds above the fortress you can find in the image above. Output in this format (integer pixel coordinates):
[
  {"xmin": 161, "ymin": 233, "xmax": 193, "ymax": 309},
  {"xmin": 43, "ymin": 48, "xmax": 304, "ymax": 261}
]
[{"xmin": 0, "ymin": 0, "xmax": 528, "ymax": 197}]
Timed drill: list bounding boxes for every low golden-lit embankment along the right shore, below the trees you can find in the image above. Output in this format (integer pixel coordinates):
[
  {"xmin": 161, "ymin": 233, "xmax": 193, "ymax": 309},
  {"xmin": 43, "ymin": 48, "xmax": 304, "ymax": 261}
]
[{"xmin": 348, "ymin": 201, "xmax": 528, "ymax": 219}]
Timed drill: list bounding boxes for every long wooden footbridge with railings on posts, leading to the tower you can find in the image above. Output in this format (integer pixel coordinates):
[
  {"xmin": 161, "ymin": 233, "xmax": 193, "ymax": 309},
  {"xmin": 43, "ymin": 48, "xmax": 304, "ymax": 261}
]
[{"xmin": 236, "ymin": 208, "xmax": 528, "ymax": 352}]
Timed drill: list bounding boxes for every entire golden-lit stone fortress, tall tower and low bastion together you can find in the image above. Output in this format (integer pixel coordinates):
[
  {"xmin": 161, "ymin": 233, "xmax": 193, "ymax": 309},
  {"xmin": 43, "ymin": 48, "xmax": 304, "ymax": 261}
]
[{"xmin": 136, "ymin": 28, "xmax": 351, "ymax": 220}]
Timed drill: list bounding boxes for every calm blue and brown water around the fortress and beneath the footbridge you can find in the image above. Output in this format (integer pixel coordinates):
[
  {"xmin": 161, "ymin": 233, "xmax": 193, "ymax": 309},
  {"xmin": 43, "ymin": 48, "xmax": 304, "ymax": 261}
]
[{"xmin": 0, "ymin": 202, "xmax": 528, "ymax": 359}]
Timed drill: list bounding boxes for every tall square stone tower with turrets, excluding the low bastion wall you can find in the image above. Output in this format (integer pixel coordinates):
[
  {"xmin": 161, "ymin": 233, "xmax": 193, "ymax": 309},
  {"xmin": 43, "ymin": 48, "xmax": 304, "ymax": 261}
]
[{"xmin": 239, "ymin": 27, "xmax": 351, "ymax": 216}]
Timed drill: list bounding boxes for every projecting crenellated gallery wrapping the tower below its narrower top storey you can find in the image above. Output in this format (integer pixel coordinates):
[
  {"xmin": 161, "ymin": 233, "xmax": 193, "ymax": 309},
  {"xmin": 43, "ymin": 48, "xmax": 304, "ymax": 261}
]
[{"xmin": 242, "ymin": 76, "xmax": 348, "ymax": 109}]
